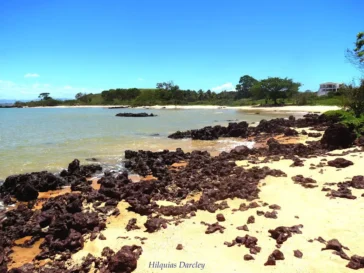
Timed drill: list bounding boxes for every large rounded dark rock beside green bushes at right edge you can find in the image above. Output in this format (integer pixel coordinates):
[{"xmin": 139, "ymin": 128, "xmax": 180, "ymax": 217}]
[{"xmin": 321, "ymin": 123, "xmax": 356, "ymax": 150}]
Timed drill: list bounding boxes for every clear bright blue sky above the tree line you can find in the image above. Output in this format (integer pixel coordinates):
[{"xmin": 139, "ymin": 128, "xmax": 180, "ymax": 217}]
[{"xmin": 0, "ymin": 0, "xmax": 364, "ymax": 99}]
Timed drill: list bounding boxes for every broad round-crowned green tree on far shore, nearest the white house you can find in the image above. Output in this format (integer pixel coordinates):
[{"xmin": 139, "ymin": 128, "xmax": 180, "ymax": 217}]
[{"xmin": 251, "ymin": 77, "xmax": 301, "ymax": 104}]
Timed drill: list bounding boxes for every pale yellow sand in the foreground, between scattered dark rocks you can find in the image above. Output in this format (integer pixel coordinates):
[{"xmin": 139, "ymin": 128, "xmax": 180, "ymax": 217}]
[{"xmin": 69, "ymin": 146, "xmax": 364, "ymax": 273}]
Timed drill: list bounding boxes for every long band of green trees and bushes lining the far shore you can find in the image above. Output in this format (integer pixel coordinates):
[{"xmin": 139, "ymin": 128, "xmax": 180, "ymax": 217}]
[{"xmin": 10, "ymin": 32, "xmax": 364, "ymax": 108}]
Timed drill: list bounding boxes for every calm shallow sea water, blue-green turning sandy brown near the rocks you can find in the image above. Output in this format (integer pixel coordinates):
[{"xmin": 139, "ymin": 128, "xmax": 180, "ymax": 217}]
[{"xmin": 0, "ymin": 108, "xmax": 290, "ymax": 180}]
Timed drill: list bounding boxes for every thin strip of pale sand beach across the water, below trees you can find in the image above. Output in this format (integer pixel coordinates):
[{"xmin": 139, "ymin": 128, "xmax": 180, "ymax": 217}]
[{"xmin": 27, "ymin": 105, "xmax": 340, "ymax": 113}]
